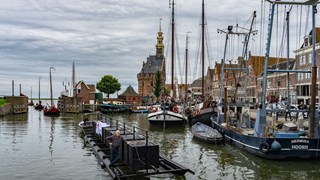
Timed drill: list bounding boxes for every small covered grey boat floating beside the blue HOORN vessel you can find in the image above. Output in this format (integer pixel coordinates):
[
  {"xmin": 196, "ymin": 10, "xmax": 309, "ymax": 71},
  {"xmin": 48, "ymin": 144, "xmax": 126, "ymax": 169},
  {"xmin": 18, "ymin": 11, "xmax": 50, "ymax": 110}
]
[{"xmin": 191, "ymin": 122, "xmax": 223, "ymax": 144}]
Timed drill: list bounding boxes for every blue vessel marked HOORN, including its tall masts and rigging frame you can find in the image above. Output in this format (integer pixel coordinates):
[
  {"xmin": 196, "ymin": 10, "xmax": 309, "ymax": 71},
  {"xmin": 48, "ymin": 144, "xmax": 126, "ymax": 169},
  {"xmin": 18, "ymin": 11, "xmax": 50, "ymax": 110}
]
[{"xmin": 211, "ymin": 0, "xmax": 320, "ymax": 160}]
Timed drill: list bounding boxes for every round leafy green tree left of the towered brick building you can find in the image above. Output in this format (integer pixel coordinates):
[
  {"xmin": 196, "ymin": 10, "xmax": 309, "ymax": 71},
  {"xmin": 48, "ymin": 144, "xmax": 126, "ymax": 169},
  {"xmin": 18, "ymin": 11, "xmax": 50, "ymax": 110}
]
[{"xmin": 97, "ymin": 75, "xmax": 121, "ymax": 98}]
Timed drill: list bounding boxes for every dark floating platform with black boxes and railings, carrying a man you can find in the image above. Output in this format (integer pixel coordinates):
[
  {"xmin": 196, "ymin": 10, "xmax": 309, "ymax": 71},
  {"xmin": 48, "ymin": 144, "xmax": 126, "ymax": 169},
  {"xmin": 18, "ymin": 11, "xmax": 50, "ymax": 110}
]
[{"xmin": 81, "ymin": 114, "xmax": 194, "ymax": 179}]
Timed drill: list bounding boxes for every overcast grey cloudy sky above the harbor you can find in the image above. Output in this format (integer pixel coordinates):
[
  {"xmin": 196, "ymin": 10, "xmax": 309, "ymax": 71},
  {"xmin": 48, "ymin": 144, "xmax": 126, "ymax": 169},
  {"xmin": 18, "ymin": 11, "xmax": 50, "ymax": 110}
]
[{"xmin": 0, "ymin": 0, "xmax": 311, "ymax": 97}]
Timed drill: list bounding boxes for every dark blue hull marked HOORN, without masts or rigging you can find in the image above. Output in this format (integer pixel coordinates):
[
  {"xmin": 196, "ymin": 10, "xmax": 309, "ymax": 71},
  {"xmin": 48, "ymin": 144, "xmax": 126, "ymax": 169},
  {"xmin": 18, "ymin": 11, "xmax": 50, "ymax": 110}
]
[{"xmin": 211, "ymin": 113, "xmax": 320, "ymax": 160}]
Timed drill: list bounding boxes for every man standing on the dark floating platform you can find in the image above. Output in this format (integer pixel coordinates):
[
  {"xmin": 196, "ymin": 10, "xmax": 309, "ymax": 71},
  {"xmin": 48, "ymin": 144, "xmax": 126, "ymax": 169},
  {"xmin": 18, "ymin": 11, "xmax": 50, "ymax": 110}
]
[{"xmin": 107, "ymin": 130, "xmax": 124, "ymax": 167}]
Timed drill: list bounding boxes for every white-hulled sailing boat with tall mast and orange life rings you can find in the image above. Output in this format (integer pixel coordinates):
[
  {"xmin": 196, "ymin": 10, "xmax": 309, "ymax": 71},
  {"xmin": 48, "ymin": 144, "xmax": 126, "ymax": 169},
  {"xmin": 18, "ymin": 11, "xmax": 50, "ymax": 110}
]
[{"xmin": 148, "ymin": 0, "xmax": 187, "ymax": 127}]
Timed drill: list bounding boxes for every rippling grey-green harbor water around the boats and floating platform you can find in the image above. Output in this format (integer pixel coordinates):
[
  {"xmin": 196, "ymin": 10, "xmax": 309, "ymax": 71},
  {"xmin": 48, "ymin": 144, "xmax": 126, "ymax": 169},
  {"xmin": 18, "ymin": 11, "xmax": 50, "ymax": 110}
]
[{"xmin": 0, "ymin": 107, "xmax": 320, "ymax": 180}]
